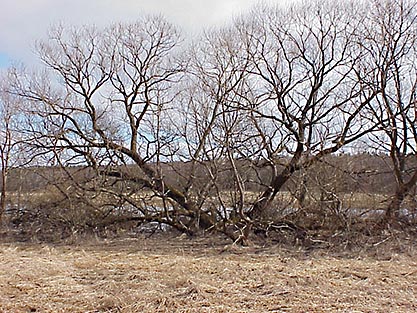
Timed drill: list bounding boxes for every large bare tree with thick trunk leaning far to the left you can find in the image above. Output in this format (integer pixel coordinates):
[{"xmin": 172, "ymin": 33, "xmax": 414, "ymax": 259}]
[{"xmin": 11, "ymin": 17, "xmax": 219, "ymax": 231}]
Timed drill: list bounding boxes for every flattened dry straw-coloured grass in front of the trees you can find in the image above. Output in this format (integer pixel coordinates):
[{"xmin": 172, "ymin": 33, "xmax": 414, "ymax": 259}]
[{"xmin": 0, "ymin": 238, "xmax": 417, "ymax": 312}]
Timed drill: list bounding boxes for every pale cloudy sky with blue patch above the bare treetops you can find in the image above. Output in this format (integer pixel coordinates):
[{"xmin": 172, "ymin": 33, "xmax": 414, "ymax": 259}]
[{"xmin": 0, "ymin": 0, "xmax": 295, "ymax": 68}]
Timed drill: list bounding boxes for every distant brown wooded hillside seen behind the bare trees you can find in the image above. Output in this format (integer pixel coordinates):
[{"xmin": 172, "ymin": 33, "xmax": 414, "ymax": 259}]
[{"xmin": 5, "ymin": 153, "xmax": 417, "ymax": 194}]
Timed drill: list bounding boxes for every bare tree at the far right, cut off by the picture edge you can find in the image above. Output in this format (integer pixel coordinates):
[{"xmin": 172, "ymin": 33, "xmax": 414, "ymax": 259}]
[{"xmin": 362, "ymin": 0, "xmax": 417, "ymax": 220}]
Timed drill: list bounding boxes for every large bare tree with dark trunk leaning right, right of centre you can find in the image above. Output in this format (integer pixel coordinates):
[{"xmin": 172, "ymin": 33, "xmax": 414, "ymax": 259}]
[{"xmin": 223, "ymin": 2, "xmax": 378, "ymax": 217}]
